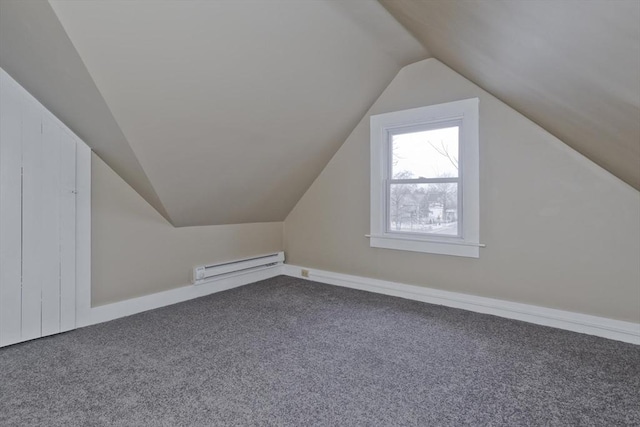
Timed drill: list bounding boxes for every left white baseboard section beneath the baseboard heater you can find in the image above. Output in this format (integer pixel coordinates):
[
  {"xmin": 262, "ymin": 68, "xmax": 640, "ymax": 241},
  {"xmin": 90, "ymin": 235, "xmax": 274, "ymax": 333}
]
[{"xmin": 77, "ymin": 265, "xmax": 282, "ymax": 328}]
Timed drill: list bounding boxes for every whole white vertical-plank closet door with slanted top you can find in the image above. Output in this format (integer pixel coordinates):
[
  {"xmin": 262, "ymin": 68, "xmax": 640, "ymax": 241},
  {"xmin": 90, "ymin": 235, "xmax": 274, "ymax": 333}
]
[{"xmin": 0, "ymin": 69, "xmax": 85, "ymax": 346}]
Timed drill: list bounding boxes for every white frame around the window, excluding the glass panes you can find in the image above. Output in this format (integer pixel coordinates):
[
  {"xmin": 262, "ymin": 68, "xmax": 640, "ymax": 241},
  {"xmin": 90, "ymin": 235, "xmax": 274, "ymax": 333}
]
[{"xmin": 369, "ymin": 98, "xmax": 481, "ymax": 258}]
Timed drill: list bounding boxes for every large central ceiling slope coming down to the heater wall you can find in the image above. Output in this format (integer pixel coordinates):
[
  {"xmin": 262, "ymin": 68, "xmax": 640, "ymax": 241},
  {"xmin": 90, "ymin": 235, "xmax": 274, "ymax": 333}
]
[{"xmin": 45, "ymin": 0, "xmax": 427, "ymax": 226}]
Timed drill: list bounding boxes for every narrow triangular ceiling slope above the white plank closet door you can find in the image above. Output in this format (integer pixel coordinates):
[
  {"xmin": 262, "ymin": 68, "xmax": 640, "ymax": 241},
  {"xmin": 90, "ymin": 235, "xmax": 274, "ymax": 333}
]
[{"xmin": 0, "ymin": 0, "xmax": 168, "ymax": 219}]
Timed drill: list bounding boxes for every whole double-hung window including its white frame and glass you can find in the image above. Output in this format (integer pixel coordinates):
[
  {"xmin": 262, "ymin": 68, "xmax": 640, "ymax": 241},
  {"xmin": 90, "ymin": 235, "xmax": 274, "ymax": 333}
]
[{"xmin": 370, "ymin": 98, "xmax": 480, "ymax": 258}]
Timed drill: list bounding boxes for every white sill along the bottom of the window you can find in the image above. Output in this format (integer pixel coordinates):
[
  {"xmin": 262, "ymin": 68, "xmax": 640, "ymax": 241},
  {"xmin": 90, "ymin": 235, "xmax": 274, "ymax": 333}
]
[{"xmin": 367, "ymin": 234, "xmax": 484, "ymax": 258}]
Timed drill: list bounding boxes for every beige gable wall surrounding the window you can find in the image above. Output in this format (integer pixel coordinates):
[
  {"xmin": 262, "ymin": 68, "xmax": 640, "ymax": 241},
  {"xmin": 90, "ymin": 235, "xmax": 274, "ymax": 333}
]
[{"xmin": 284, "ymin": 59, "xmax": 640, "ymax": 322}]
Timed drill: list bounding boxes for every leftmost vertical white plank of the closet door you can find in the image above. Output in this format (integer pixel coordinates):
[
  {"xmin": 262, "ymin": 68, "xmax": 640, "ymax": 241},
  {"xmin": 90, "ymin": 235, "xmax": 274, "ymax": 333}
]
[{"xmin": 0, "ymin": 75, "xmax": 22, "ymax": 346}]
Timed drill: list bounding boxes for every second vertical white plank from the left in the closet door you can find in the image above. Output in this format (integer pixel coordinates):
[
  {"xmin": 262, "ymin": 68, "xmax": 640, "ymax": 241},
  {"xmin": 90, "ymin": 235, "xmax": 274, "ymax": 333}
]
[{"xmin": 22, "ymin": 102, "xmax": 45, "ymax": 340}]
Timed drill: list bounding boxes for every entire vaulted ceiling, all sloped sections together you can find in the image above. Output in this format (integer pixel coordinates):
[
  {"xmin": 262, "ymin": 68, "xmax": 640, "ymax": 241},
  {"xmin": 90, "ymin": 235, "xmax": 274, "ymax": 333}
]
[{"xmin": 0, "ymin": 0, "xmax": 640, "ymax": 226}]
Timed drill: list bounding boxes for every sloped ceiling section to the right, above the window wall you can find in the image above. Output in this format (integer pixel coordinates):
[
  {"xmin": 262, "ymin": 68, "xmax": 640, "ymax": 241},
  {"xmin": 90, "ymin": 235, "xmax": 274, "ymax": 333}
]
[{"xmin": 380, "ymin": 0, "xmax": 640, "ymax": 189}]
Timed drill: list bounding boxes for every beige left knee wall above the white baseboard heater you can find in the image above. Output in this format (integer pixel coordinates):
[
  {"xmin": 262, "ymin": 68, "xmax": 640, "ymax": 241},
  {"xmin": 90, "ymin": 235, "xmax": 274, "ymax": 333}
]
[{"xmin": 91, "ymin": 154, "xmax": 282, "ymax": 307}]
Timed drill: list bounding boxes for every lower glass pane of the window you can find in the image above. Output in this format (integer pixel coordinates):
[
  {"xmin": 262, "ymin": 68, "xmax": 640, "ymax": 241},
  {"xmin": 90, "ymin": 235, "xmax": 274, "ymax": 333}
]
[{"xmin": 389, "ymin": 183, "xmax": 460, "ymax": 236}]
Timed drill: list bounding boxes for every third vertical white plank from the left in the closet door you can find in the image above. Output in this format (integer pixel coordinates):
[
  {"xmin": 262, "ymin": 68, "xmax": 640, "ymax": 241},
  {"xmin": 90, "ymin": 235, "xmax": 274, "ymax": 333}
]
[{"xmin": 41, "ymin": 118, "xmax": 63, "ymax": 336}]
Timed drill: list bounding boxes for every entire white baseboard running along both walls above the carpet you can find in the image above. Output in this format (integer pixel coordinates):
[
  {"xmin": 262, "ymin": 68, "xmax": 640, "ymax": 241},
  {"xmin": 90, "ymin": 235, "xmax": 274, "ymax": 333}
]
[{"xmin": 72, "ymin": 264, "xmax": 640, "ymax": 345}]
